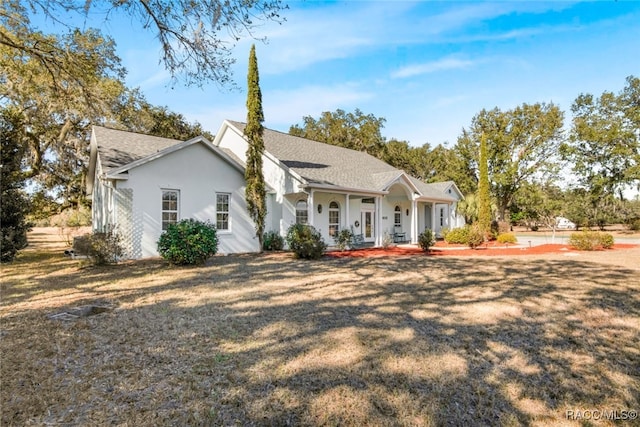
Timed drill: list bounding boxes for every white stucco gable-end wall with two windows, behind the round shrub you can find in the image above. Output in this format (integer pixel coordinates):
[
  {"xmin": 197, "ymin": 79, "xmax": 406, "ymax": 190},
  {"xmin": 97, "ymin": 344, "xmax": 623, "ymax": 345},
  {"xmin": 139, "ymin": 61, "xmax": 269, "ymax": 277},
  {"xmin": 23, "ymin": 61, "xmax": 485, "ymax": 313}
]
[{"xmin": 117, "ymin": 143, "xmax": 259, "ymax": 257}]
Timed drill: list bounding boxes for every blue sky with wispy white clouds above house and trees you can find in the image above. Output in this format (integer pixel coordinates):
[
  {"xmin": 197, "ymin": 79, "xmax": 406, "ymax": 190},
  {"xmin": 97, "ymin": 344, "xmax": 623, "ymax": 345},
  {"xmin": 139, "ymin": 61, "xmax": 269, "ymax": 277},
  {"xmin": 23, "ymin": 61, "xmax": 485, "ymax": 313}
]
[{"xmin": 41, "ymin": 1, "xmax": 640, "ymax": 146}]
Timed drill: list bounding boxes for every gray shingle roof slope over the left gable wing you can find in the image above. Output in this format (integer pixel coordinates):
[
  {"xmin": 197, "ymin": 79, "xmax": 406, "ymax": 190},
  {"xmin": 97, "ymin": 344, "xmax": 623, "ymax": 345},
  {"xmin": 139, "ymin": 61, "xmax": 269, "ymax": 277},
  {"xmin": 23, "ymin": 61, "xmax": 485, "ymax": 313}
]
[{"xmin": 93, "ymin": 126, "xmax": 183, "ymax": 171}]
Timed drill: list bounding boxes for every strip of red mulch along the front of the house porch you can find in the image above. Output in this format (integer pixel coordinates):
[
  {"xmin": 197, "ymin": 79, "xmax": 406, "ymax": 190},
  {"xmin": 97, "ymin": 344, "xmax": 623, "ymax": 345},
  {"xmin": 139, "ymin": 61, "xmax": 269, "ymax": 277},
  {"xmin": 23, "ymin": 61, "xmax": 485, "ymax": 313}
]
[{"xmin": 327, "ymin": 243, "xmax": 638, "ymax": 258}]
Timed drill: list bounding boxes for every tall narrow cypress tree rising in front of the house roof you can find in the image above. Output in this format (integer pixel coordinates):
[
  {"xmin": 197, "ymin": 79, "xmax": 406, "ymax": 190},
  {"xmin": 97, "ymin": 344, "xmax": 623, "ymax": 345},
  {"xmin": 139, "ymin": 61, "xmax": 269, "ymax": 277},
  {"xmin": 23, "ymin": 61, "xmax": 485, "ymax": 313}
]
[{"xmin": 244, "ymin": 45, "xmax": 267, "ymax": 250}]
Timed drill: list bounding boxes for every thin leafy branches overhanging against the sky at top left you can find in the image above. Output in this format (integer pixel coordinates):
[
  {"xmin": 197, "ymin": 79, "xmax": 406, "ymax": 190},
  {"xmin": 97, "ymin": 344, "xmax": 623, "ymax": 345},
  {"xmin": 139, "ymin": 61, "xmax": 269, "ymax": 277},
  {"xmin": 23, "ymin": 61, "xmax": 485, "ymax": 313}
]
[{"xmin": 0, "ymin": 0, "xmax": 287, "ymax": 86}]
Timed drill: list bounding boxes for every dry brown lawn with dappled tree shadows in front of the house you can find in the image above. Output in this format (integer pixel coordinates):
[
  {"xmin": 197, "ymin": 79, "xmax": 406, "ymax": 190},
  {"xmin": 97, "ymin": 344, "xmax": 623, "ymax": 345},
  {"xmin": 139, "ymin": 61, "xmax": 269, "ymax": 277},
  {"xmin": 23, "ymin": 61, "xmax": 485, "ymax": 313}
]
[{"xmin": 0, "ymin": 230, "xmax": 640, "ymax": 426}]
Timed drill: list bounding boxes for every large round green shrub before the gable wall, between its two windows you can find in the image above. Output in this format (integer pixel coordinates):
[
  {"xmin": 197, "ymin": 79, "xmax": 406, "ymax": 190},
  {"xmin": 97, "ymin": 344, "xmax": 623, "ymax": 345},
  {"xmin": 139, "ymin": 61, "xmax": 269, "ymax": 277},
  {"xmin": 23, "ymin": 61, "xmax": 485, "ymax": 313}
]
[{"xmin": 158, "ymin": 219, "xmax": 218, "ymax": 265}]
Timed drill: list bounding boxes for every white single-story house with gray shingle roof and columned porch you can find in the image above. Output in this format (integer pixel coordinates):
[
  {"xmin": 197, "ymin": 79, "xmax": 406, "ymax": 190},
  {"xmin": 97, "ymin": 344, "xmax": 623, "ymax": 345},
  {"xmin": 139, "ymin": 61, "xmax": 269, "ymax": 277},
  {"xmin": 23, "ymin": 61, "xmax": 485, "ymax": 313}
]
[{"xmin": 87, "ymin": 120, "xmax": 464, "ymax": 258}]
